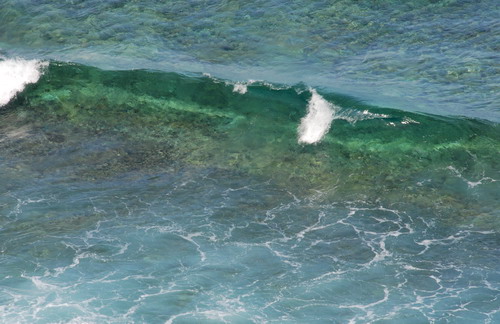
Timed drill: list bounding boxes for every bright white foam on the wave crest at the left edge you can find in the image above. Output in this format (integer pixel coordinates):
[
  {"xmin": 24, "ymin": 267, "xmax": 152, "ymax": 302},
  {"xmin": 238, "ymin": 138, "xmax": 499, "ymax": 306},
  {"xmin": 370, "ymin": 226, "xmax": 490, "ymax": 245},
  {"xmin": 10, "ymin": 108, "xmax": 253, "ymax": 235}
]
[{"xmin": 0, "ymin": 59, "xmax": 48, "ymax": 107}]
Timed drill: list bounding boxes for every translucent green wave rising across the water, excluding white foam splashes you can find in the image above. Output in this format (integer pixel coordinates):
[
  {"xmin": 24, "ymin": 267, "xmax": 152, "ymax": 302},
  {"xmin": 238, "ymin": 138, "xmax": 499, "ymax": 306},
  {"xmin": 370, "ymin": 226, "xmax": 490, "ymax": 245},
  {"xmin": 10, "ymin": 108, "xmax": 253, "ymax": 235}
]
[{"xmin": 0, "ymin": 62, "xmax": 500, "ymax": 226}]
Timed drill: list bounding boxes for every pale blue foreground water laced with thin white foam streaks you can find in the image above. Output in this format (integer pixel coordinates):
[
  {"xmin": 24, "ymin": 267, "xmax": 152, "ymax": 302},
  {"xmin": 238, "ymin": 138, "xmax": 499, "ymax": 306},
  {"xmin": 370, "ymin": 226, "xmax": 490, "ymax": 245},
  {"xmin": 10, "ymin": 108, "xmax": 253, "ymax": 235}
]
[{"xmin": 0, "ymin": 170, "xmax": 500, "ymax": 323}]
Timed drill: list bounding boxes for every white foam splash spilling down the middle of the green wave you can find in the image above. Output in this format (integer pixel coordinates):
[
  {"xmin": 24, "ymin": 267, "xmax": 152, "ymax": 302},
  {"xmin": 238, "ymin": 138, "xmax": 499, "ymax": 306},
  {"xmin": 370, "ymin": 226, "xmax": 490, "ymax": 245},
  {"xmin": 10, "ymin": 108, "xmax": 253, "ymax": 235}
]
[{"xmin": 298, "ymin": 89, "xmax": 338, "ymax": 144}]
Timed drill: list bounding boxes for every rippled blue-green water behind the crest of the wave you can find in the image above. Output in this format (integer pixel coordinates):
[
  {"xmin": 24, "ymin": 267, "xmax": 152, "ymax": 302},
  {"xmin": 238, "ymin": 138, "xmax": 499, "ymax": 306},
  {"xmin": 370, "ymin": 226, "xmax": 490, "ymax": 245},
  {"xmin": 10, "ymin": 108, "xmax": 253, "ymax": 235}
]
[{"xmin": 0, "ymin": 0, "xmax": 500, "ymax": 122}]
